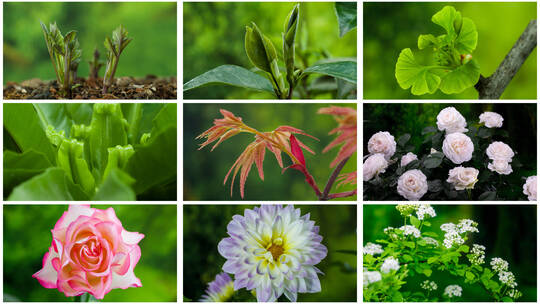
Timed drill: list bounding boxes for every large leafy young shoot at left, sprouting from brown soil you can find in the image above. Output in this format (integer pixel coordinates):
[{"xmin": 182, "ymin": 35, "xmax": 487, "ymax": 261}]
[{"xmin": 40, "ymin": 21, "xmax": 82, "ymax": 98}]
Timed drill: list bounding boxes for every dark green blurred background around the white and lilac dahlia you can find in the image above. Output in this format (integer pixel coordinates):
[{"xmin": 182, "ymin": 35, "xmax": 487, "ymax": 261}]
[{"xmin": 183, "ymin": 205, "xmax": 357, "ymax": 302}]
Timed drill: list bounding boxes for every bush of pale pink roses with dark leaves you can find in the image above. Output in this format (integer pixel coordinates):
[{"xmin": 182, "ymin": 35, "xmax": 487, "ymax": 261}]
[{"xmin": 364, "ymin": 107, "xmax": 536, "ymax": 200}]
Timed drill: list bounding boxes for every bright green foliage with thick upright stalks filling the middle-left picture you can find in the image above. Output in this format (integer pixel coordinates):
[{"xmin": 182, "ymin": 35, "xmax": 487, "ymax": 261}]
[{"xmin": 4, "ymin": 104, "xmax": 176, "ymax": 200}]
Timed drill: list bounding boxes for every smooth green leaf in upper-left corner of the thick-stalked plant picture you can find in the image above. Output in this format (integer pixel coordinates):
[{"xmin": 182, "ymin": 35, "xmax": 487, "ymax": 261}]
[{"xmin": 4, "ymin": 103, "xmax": 56, "ymax": 164}]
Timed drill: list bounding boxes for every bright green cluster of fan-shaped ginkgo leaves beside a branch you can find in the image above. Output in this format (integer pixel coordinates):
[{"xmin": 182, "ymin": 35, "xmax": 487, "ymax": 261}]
[{"xmin": 396, "ymin": 6, "xmax": 480, "ymax": 95}]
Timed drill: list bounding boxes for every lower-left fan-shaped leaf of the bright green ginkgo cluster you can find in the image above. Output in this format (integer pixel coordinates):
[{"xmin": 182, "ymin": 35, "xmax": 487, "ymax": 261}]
[{"xmin": 395, "ymin": 48, "xmax": 441, "ymax": 95}]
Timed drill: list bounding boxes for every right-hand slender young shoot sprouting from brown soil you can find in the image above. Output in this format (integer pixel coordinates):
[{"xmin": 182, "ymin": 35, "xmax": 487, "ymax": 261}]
[{"xmin": 103, "ymin": 25, "xmax": 133, "ymax": 94}]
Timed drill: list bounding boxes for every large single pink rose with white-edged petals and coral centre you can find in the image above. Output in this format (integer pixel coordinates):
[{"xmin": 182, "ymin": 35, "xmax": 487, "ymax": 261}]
[{"xmin": 32, "ymin": 205, "xmax": 144, "ymax": 299}]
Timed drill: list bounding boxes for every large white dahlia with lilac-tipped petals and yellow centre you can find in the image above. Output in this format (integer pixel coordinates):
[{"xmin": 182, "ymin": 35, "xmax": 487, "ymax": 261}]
[{"xmin": 218, "ymin": 205, "xmax": 328, "ymax": 302}]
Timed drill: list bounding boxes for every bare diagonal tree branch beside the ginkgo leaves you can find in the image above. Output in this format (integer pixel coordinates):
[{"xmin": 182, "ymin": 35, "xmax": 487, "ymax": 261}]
[{"xmin": 475, "ymin": 20, "xmax": 537, "ymax": 99}]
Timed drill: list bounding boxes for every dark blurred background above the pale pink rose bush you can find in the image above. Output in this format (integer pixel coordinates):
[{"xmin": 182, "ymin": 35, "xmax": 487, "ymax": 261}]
[{"xmin": 363, "ymin": 103, "xmax": 537, "ymax": 178}]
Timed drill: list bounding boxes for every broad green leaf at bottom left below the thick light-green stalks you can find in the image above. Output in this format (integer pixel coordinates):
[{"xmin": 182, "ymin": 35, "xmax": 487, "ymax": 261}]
[{"xmin": 8, "ymin": 168, "xmax": 89, "ymax": 201}]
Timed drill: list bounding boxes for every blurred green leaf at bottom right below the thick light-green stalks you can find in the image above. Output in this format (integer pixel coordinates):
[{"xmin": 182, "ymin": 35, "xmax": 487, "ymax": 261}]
[{"xmin": 93, "ymin": 169, "xmax": 136, "ymax": 201}]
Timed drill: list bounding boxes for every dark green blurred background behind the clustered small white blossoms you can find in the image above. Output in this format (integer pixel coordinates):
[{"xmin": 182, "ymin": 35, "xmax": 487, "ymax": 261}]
[{"xmin": 363, "ymin": 205, "xmax": 537, "ymax": 302}]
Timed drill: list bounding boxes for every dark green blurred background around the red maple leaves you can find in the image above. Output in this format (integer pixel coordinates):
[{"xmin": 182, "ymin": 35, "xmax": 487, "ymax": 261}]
[{"xmin": 183, "ymin": 103, "xmax": 356, "ymax": 201}]
